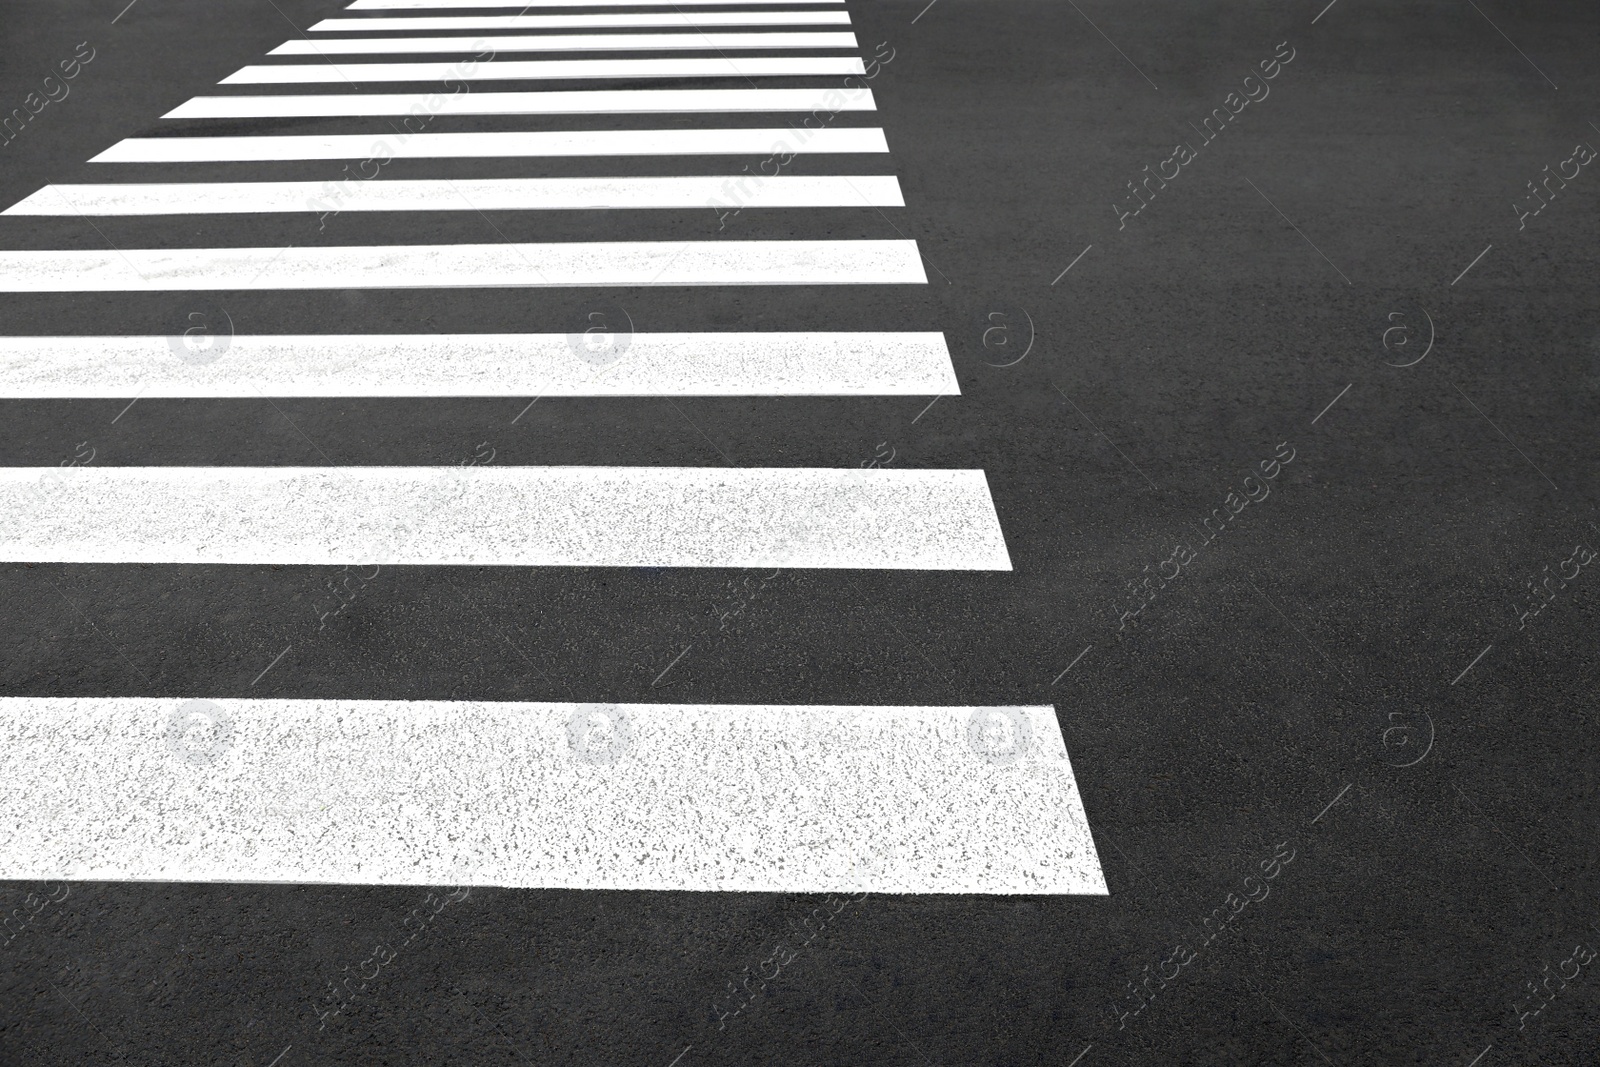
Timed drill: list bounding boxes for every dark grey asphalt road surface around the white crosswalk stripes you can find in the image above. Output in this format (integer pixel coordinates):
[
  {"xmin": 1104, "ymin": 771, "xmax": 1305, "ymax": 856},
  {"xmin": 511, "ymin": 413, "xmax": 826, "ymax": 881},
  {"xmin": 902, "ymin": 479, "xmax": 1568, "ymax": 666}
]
[{"xmin": 0, "ymin": 0, "xmax": 1600, "ymax": 1067}]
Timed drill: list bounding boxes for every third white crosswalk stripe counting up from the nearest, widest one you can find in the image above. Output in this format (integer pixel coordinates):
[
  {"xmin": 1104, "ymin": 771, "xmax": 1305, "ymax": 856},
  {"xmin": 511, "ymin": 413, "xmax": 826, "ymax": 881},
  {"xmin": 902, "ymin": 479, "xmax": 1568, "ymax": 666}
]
[{"xmin": 0, "ymin": 331, "xmax": 962, "ymax": 400}]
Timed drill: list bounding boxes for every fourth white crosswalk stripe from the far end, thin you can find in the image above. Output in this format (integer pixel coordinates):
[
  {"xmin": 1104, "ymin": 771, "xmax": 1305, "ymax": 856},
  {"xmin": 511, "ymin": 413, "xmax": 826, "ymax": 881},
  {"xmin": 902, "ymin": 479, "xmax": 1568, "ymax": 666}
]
[{"xmin": 218, "ymin": 56, "xmax": 866, "ymax": 88}]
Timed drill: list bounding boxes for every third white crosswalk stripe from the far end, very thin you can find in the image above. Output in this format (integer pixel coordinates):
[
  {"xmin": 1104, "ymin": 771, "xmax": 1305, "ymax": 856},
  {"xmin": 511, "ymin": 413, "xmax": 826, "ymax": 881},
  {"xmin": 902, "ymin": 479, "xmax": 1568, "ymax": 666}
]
[{"xmin": 267, "ymin": 30, "xmax": 859, "ymax": 56}]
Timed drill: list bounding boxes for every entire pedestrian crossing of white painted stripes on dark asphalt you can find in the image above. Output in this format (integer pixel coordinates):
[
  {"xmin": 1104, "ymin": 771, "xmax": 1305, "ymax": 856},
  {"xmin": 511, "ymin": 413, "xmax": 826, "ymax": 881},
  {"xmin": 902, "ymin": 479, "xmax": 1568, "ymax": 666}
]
[{"xmin": 0, "ymin": 0, "xmax": 1106, "ymax": 893}]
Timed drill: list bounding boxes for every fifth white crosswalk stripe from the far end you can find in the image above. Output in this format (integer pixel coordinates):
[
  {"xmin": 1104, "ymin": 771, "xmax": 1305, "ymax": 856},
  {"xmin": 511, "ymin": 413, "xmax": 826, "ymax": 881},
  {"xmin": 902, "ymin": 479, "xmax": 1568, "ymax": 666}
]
[{"xmin": 157, "ymin": 90, "xmax": 882, "ymax": 120}]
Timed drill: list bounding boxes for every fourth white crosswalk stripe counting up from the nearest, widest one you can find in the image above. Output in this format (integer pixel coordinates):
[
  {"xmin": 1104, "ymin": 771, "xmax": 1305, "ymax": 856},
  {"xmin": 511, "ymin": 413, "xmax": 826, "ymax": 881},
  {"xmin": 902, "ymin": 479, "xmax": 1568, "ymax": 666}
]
[{"xmin": 0, "ymin": 238, "xmax": 928, "ymax": 293}]
